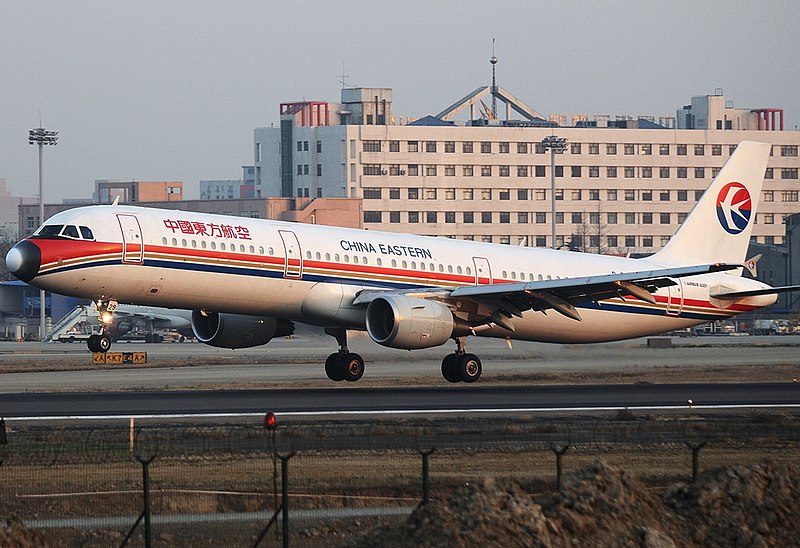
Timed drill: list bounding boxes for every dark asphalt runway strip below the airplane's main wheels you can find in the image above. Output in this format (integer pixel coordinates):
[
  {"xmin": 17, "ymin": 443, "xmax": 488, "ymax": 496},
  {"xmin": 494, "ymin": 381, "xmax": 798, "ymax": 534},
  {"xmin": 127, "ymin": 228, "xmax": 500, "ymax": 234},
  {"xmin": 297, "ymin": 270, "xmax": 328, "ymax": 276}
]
[{"xmin": 0, "ymin": 383, "xmax": 800, "ymax": 420}]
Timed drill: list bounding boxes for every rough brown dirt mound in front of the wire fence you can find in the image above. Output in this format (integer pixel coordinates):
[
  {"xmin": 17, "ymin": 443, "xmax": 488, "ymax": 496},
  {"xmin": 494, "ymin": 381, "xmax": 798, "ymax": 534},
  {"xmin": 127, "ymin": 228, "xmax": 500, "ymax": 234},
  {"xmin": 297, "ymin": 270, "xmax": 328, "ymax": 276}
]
[{"xmin": 350, "ymin": 461, "xmax": 800, "ymax": 548}]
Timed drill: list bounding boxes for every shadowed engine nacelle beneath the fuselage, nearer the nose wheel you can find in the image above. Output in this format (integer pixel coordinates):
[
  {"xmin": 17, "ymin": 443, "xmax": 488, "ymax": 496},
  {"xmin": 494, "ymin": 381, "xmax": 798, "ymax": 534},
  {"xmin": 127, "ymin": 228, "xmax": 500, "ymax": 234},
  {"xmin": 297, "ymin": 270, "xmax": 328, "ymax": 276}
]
[{"xmin": 192, "ymin": 310, "xmax": 294, "ymax": 348}]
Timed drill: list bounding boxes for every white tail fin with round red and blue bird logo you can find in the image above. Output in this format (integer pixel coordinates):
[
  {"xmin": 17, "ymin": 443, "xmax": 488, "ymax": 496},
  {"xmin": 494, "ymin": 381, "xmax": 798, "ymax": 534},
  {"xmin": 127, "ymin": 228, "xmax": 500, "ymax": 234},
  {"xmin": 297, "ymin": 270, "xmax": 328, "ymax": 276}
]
[{"xmin": 652, "ymin": 141, "xmax": 771, "ymax": 264}]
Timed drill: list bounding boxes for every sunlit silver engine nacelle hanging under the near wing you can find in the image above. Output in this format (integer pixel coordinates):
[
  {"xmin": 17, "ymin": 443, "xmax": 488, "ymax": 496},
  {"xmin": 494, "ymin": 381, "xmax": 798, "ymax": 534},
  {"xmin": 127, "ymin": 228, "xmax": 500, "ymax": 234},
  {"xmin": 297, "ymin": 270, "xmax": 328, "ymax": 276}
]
[{"xmin": 366, "ymin": 295, "xmax": 454, "ymax": 350}]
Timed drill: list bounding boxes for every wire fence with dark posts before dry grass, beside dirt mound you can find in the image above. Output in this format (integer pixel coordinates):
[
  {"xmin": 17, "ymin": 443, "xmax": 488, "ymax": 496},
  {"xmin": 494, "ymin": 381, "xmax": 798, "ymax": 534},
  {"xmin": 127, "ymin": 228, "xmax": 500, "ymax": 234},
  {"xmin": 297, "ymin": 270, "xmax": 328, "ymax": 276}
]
[{"xmin": 0, "ymin": 411, "xmax": 800, "ymax": 546}]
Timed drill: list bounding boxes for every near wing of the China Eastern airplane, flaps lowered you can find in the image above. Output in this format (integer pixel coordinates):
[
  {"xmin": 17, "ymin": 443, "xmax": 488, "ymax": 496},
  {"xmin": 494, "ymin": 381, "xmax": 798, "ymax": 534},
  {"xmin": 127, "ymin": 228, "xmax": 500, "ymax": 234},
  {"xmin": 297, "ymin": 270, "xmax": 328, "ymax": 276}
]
[{"xmin": 353, "ymin": 264, "xmax": 741, "ymax": 331}]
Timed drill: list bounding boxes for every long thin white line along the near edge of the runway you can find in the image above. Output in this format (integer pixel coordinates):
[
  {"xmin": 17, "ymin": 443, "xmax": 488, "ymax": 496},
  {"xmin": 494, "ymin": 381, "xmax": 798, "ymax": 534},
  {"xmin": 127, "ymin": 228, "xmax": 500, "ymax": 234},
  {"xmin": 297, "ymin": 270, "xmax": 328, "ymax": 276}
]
[{"xmin": 9, "ymin": 403, "xmax": 800, "ymax": 422}]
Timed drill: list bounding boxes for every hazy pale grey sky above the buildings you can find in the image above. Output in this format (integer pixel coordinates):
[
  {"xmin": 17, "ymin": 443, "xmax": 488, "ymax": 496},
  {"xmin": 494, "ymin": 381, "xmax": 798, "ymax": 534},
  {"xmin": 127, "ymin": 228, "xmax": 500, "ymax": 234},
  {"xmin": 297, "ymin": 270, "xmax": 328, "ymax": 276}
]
[{"xmin": 0, "ymin": 0, "xmax": 800, "ymax": 203}]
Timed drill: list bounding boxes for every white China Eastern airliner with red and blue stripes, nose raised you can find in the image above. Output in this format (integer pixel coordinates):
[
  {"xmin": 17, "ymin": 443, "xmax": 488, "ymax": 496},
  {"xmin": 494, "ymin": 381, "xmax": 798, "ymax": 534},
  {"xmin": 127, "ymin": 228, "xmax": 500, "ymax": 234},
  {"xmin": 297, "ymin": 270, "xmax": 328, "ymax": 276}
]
[{"xmin": 6, "ymin": 141, "xmax": 798, "ymax": 383}]
